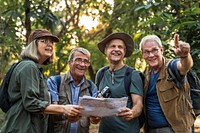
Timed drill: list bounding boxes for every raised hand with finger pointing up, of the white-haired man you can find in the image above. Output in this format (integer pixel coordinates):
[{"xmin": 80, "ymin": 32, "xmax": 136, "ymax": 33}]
[{"xmin": 174, "ymin": 34, "xmax": 190, "ymax": 58}]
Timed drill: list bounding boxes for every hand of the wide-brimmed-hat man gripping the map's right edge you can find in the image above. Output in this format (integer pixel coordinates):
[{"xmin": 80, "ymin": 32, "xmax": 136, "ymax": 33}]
[{"xmin": 117, "ymin": 108, "xmax": 134, "ymax": 121}]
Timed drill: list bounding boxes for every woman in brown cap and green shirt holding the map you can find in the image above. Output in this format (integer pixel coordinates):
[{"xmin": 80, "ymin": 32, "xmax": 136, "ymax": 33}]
[{"xmin": 1, "ymin": 29, "xmax": 83, "ymax": 133}]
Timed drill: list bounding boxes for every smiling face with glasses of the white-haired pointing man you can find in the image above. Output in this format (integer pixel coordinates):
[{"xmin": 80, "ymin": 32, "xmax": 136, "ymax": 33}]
[{"xmin": 141, "ymin": 40, "xmax": 163, "ymax": 69}]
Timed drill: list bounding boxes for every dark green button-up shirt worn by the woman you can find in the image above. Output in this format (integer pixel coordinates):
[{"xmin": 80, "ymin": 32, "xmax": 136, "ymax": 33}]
[{"xmin": 1, "ymin": 60, "xmax": 50, "ymax": 133}]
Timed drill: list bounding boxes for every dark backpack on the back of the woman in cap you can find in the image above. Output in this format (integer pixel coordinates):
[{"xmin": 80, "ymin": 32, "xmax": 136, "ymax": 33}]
[{"xmin": 0, "ymin": 62, "xmax": 20, "ymax": 113}]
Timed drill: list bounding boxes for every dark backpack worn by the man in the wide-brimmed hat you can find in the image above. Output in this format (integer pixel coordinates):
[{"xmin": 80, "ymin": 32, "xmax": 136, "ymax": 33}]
[{"xmin": 96, "ymin": 66, "xmax": 145, "ymax": 128}]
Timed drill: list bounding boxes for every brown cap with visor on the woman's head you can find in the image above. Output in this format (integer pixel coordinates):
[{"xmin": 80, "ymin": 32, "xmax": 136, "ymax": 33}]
[{"xmin": 28, "ymin": 29, "xmax": 59, "ymax": 43}]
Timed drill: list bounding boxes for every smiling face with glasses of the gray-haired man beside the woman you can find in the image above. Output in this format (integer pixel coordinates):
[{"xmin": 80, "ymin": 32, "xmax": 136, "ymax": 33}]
[{"xmin": 68, "ymin": 51, "xmax": 90, "ymax": 79}]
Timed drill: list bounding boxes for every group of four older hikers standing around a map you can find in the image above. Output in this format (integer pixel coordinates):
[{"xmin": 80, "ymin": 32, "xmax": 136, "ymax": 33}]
[{"xmin": 1, "ymin": 29, "xmax": 195, "ymax": 133}]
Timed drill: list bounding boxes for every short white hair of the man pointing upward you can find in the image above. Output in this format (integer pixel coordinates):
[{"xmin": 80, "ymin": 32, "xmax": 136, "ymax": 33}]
[{"xmin": 140, "ymin": 35, "xmax": 162, "ymax": 50}]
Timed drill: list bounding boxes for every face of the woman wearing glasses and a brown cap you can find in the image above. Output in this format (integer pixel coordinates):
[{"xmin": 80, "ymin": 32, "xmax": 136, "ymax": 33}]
[{"xmin": 37, "ymin": 37, "xmax": 54, "ymax": 60}]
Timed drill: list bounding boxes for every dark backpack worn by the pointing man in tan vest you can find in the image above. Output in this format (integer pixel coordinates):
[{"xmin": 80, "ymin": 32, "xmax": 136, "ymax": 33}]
[{"xmin": 167, "ymin": 60, "xmax": 200, "ymax": 116}]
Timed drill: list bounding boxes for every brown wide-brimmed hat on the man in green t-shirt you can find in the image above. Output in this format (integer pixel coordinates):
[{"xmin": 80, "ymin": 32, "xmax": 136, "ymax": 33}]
[{"xmin": 98, "ymin": 33, "xmax": 134, "ymax": 57}]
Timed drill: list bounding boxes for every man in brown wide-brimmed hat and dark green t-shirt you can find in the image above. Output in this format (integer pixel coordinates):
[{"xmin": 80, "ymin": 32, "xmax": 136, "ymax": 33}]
[{"xmin": 92, "ymin": 33, "xmax": 143, "ymax": 133}]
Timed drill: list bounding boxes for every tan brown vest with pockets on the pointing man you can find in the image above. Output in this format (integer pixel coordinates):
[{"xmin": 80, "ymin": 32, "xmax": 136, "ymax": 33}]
[{"xmin": 144, "ymin": 58, "xmax": 195, "ymax": 133}]
